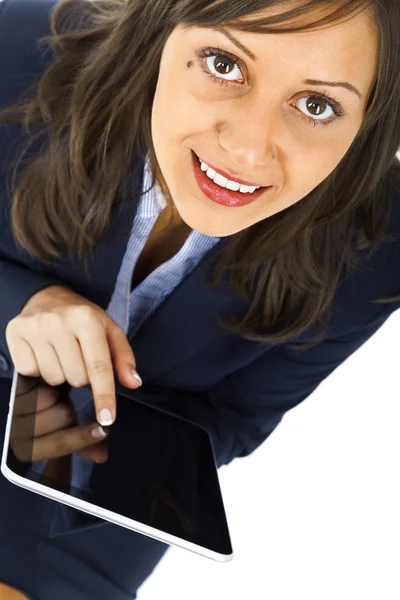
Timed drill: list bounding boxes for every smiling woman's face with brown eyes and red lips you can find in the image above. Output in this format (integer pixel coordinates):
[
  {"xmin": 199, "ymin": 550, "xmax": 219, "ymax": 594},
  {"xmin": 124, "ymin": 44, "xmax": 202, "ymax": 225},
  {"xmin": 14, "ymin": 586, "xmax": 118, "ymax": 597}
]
[{"xmin": 152, "ymin": 11, "xmax": 378, "ymax": 237}]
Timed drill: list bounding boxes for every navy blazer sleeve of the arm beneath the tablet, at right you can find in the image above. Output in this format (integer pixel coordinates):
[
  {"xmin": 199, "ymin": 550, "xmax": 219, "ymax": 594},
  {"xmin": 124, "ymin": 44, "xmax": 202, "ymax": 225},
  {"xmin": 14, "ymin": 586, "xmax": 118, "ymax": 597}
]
[{"xmin": 129, "ymin": 308, "xmax": 390, "ymax": 466}]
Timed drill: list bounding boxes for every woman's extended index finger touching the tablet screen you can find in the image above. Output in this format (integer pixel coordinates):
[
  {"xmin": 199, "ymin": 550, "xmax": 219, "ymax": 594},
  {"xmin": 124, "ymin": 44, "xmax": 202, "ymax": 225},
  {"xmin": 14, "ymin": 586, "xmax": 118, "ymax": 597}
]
[{"xmin": 78, "ymin": 323, "xmax": 117, "ymax": 425}]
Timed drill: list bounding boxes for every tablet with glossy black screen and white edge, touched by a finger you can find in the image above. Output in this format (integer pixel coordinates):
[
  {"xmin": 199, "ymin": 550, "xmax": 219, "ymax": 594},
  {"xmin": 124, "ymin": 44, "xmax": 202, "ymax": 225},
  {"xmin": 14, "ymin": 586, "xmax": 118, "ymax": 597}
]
[{"xmin": 0, "ymin": 370, "xmax": 233, "ymax": 562}]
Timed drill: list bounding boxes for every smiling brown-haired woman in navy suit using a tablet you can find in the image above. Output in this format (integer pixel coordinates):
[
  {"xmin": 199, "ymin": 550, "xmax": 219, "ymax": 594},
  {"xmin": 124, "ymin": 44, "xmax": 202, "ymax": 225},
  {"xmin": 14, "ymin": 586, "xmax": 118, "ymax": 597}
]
[{"xmin": 0, "ymin": 0, "xmax": 400, "ymax": 600}]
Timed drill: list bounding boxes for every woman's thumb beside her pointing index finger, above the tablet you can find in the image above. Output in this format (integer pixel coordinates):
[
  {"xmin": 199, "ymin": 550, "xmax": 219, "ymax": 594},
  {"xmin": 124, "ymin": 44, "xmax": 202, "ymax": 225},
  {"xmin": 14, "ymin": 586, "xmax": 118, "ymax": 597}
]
[{"xmin": 107, "ymin": 318, "xmax": 142, "ymax": 388}]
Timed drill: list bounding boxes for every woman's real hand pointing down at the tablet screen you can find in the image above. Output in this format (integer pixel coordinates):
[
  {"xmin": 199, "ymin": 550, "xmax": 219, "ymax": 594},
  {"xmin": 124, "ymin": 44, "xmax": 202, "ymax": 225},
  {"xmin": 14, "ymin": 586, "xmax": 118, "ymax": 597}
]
[{"xmin": 5, "ymin": 285, "xmax": 142, "ymax": 425}]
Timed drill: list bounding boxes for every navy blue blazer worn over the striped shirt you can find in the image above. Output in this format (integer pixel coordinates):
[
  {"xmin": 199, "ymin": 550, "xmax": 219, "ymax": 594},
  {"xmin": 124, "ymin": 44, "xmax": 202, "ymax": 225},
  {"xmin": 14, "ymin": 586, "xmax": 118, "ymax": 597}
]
[{"xmin": 0, "ymin": 0, "xmax": 400, "ymax": 465}]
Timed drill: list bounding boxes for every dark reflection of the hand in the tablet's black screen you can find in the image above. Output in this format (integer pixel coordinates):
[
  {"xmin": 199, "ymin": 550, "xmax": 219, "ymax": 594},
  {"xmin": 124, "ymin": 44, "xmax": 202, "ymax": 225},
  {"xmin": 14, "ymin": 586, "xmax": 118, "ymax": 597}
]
[{"xmin": 10, "ymin": 376, "xmax": 108, "ymax": 466}]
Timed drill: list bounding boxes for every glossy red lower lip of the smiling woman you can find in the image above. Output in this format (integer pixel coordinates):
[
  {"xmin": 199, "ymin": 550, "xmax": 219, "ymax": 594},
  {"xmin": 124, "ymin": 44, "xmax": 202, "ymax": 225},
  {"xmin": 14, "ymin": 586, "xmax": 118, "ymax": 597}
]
[{"xmin": 192, "ymin": 150, "xmax": 272, "ymax": 208}]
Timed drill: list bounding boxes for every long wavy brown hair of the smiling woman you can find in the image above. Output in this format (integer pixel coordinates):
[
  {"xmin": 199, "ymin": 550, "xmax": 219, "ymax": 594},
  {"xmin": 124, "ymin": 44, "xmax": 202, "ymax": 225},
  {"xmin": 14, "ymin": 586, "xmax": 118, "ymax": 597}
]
[{"xmin": 0, "ymin": 0, "xmax": 400, "ymax": 349}]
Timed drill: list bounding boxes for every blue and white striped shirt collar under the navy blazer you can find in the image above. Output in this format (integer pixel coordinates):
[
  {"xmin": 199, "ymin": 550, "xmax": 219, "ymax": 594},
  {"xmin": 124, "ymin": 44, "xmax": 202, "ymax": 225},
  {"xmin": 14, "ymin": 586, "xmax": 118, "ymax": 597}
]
[{"xmin": 106, "ymin": 155, "xmax": 220, "ymax": 339}]
